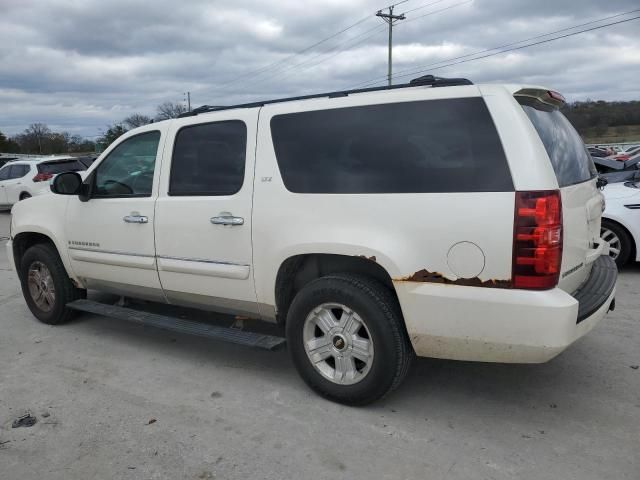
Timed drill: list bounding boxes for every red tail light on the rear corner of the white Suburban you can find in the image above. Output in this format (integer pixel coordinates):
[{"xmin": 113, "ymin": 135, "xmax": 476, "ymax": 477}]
[{"xmin": 512, "ymin": 190, "xmax": 562, "ymax": 290}]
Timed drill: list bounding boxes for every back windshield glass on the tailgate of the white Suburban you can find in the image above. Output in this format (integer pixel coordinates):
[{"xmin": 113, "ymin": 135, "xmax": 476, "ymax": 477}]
[{"xmin": 517, "ymin": 97, "xmax": 597, "ymax": 187}]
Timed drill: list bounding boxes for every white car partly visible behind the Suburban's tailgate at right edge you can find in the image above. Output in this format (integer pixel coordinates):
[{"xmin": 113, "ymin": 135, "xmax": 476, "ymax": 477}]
[{"xmin": 601, "ymin": 181, "xmax": 640, "ymax": 266}]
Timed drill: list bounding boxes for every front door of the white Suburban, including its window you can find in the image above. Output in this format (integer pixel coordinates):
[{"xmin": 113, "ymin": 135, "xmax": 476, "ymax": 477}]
[{"xmin": 66, "ymin": 125, "xmax": 166, "ymax": 301}]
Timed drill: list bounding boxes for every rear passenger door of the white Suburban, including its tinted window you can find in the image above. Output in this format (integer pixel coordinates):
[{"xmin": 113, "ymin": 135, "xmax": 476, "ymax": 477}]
[{"xmin": 155, "ymin": 110, "xmax": 258, "ymax": 315}]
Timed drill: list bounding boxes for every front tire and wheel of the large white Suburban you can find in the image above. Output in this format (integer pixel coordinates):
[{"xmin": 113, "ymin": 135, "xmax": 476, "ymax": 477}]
[{"xmin": 20, "ymin": 243, "xmax": 87, "ymax": 325}]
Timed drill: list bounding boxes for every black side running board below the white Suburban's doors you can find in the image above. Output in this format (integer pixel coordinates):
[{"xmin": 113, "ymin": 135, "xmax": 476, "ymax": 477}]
[{"xmin": 67, "ymin": 300, "xmax": 286, "ymax": 350}]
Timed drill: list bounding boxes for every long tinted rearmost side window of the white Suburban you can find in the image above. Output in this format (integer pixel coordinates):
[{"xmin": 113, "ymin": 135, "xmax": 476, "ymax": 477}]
[{"xmin": 271, "ymin": 98, "xmax": 513, "ymax": 193}]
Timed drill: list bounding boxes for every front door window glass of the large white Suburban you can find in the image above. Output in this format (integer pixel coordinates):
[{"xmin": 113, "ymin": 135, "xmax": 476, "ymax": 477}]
[{"xmin": 93, "ymin": 131, "xmax": 160, "ymax": 198}]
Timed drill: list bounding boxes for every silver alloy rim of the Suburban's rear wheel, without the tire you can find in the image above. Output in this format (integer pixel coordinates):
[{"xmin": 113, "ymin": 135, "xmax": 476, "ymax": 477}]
[{"xmin": 302, "ymin": 303, "xmax": 374, "ymax": 385}]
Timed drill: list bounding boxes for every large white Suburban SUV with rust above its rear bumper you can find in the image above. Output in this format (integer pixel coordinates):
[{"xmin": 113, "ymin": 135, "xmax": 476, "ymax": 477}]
[{"xmin": 7, "ymin": 77, "xmax": 617, "ymax": 404}]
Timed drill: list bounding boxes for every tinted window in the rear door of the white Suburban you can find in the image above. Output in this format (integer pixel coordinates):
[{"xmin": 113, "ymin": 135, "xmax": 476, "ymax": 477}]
[{"xmin": 169, "ymin": 120, "xmax": 247, "ymax": 196}]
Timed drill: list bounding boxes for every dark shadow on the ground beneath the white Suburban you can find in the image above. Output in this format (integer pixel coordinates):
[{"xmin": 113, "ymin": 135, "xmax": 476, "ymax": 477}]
[{"xmin": 58, "ymin": 286, "xmax": 620, "ymax": 416}]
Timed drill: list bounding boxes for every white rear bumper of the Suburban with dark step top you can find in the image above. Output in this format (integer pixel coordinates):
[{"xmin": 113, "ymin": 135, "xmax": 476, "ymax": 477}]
[{"xmin": 395, "ymin": 256, "xmax": 617, "ymax": 363}]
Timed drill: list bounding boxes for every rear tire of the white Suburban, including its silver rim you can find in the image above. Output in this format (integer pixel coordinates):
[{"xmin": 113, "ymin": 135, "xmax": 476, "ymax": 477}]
[{"xmin": 286, "ymin": 274, "xmax": 415, "ymax": 406}]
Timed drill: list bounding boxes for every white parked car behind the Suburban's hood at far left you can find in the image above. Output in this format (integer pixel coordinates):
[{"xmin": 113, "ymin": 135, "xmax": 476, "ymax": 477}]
[{"xmin": 0, "ymin": 156, "xmax": 86, "ymax": 209}]
